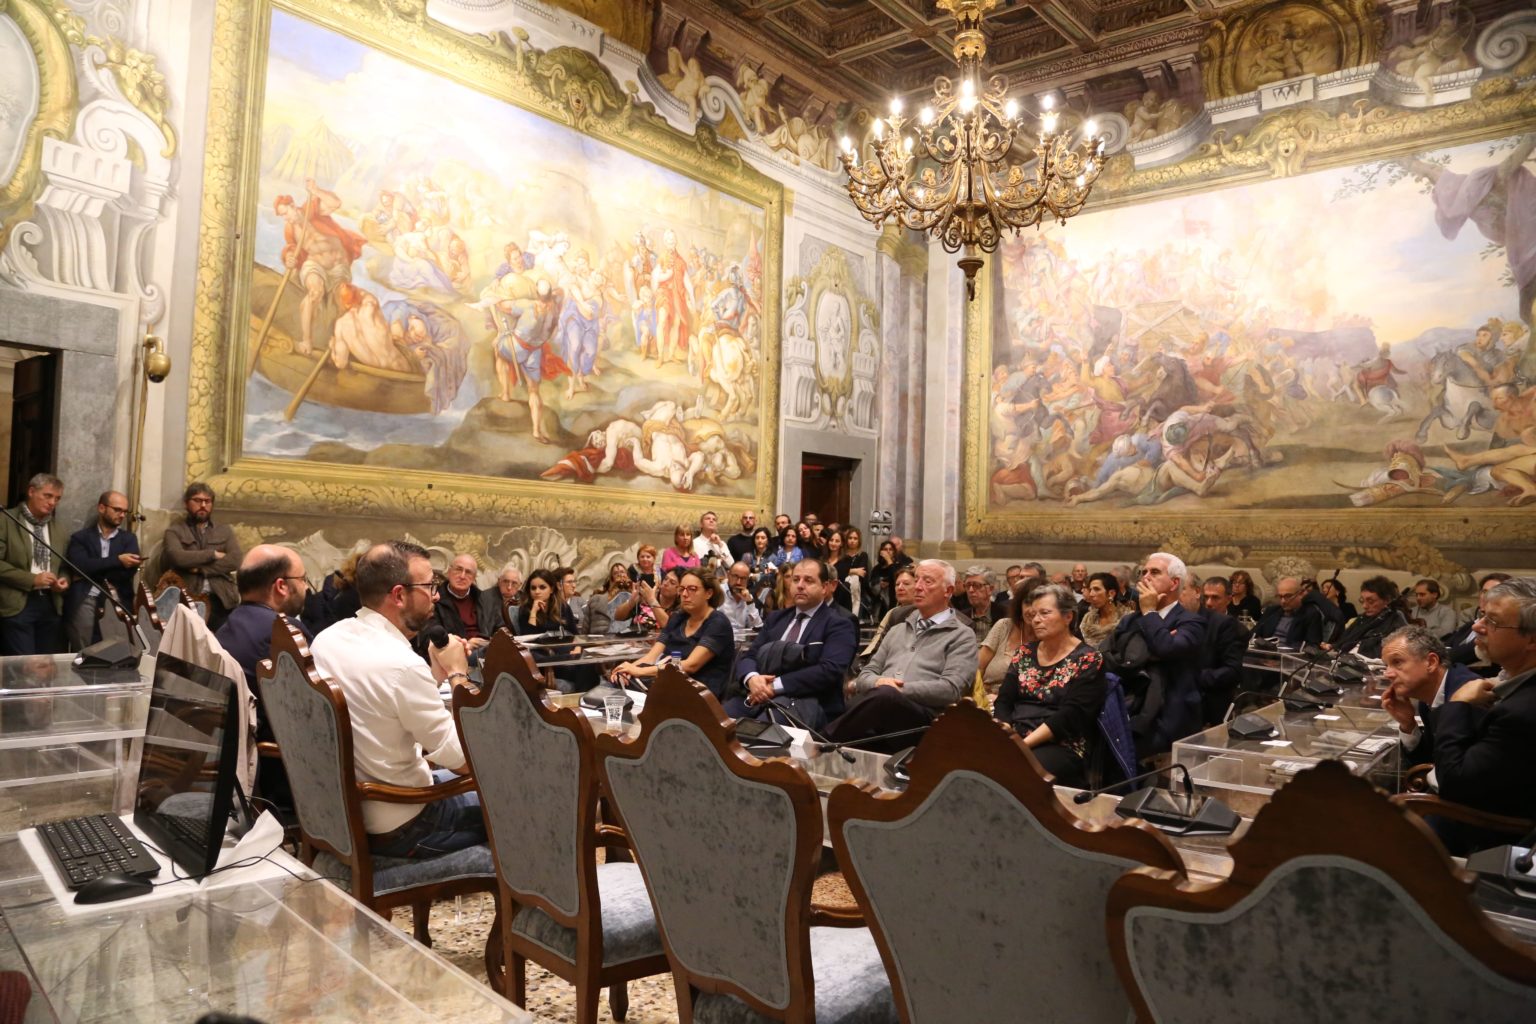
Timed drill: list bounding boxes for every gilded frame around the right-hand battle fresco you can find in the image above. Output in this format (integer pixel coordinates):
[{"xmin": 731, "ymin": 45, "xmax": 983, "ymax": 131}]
[{"xmin": 960, "ymin": 77, "xmax": 1536, "ymax": 576}]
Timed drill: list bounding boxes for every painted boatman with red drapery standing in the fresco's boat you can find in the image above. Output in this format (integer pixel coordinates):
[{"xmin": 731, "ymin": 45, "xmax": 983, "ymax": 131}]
[{"xmin": 272, "ymin": 178, "xmax": 367, "ymax": 356}]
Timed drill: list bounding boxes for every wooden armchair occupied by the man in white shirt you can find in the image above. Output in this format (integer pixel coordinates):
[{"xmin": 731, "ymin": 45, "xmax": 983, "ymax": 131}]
[{"xmin": 257, "ymin": 617, "xmax": 501, "ymax": 973}]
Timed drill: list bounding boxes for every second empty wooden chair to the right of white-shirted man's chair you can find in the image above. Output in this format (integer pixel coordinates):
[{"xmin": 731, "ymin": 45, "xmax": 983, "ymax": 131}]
[{"xmin": 594, "ymin": 666, "xmax": 897, "ymax": 1024}]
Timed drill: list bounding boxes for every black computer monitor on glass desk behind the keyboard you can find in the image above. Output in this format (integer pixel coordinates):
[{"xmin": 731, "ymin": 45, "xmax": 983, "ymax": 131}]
[{"xmin": 134, "ymin": 651, "xmax": 240, "ymax": 877}]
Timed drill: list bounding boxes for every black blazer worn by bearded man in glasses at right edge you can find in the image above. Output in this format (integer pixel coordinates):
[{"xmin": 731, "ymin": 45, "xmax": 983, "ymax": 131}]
[{"xmin": 1421, "ymin": 672, "xmax": 1536, "ymax": 818}]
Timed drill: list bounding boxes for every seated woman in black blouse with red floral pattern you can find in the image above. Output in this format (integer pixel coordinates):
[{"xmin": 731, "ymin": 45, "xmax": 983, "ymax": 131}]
[{"xmin": 992, "ymin": 583, "xmax": 1106, "ymax": 786}]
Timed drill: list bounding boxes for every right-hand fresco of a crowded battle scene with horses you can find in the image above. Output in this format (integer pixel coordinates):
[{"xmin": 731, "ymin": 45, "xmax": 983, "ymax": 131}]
[{"xmin": 985, "ymin": 135, "xmax": 1536, "ymax": 514}]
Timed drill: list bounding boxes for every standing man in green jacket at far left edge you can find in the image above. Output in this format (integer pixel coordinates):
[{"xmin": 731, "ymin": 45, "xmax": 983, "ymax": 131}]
[{"xmin": 0, "ymin": 473, "xmax": 69, "ymax": 656}]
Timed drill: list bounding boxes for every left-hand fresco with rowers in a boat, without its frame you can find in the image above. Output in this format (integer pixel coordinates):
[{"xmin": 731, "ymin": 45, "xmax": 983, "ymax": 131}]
[{"xmin": 243, "ymin": 12, "xmax": 765, "ymax": 496}]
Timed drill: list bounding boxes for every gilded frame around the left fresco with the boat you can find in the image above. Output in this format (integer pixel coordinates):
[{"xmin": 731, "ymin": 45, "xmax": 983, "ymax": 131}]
[{"xmin": 186, "ymin": 0, "xmax": 786, "ymax": 533}]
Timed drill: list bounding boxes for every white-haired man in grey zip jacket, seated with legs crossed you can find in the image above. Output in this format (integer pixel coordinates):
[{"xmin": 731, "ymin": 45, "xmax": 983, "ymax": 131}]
[{"xmin": 826, "ymin": 559, "xmax": 977, "ymax": 751}]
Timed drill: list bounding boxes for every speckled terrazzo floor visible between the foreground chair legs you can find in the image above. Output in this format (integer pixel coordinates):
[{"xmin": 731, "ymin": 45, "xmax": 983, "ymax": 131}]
[{"xmin": 393, "ymin": 872, "xmax": 852, "ymax": 1024}]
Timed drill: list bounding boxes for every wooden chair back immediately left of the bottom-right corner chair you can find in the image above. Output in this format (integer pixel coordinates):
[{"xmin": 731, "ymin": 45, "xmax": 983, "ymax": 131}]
[{"xmin": 826, "ymin": 703, "xmax": 1183, "ymax": 1024}]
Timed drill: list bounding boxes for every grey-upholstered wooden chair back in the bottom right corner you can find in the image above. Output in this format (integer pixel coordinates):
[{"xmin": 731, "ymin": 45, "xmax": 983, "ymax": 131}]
[{"xmin": 1109, "ymin": 761, "xmax": 1536, "ymax": 1024}]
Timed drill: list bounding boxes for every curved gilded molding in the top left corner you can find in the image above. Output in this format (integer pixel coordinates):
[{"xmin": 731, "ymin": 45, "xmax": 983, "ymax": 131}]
[{"xmin": 0, "ymin": 0, "xmax": 80, "ymax": 250}]
